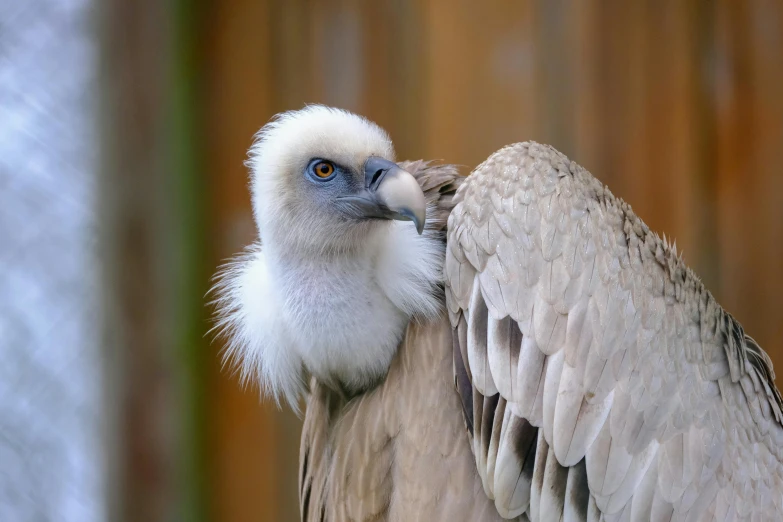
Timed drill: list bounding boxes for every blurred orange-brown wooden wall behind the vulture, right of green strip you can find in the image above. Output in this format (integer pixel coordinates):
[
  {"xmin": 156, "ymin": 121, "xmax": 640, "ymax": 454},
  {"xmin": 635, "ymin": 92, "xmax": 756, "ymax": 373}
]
[{"xmin": 104, "ymin": 0, "xmax": 783, "ymax": 522}]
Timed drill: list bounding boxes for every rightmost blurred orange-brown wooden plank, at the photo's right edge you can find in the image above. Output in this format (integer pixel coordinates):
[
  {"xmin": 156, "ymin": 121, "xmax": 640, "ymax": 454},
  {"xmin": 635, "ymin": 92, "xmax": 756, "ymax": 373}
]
[{"xmin": 715, "ymin": 1, "xmax": 783, "ymax": 374}]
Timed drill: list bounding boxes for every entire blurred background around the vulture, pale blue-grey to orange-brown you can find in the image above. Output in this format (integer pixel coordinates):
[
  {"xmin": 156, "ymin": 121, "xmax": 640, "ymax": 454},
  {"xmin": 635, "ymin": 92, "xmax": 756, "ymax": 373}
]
[{"xmin": 0, "ymin": 0, "xmax": 783, "ymax": 522}]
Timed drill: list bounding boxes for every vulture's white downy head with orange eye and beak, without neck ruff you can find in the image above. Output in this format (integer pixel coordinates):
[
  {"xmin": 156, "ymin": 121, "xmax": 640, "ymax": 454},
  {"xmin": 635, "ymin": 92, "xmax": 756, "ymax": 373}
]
[{"xmin": 249, "ymin": 106, "xmax": 425, "ymax": 257}]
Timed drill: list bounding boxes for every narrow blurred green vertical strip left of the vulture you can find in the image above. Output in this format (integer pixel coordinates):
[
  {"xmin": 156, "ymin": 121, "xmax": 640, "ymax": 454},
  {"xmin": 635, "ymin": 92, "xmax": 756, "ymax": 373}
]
[{"xmin": 170, "ymin": 0, "xmax": 211, "ymax": 522}]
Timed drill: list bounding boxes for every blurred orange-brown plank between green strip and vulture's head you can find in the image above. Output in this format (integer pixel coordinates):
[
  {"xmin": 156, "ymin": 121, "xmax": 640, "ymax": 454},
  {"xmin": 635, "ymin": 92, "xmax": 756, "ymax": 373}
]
[{"xmin": 204, "ymin": 0, "xmax": 301, "ymax": 522}]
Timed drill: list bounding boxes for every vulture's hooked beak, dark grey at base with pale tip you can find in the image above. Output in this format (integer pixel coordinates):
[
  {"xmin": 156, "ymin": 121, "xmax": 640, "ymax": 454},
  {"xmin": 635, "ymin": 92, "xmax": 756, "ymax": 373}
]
[{"xmin": 337, "ymin": 156, "xmax": 427, "ymax": 234}]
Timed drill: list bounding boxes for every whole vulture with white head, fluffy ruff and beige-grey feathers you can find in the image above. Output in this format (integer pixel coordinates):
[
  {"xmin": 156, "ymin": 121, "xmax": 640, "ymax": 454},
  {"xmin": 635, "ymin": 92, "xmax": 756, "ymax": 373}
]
[{"xmin": 215, "ymin": 105, "xmax": 783, "ymax": 522}]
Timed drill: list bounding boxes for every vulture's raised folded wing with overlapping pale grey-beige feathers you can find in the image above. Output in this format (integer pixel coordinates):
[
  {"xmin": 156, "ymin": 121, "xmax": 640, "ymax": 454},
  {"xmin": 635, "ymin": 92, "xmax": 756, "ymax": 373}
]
[{"xmin": 445, "ymin": 143, "xmax": 783, "ymax": 521}]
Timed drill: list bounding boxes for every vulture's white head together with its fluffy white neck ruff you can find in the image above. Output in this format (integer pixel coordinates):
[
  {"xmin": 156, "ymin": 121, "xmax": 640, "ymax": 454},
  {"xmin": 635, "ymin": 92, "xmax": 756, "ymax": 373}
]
[{"xmin": 216, "ymin": 106, "xmax": 443, "ymax": 407}]
